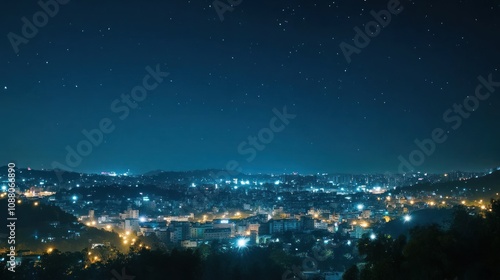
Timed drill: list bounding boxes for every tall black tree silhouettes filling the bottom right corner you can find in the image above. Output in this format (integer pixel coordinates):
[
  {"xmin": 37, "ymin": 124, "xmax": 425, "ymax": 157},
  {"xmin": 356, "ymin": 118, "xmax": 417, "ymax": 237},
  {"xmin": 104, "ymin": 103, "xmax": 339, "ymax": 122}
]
[{"xmin": 343, "ymin": 200, "xmax": 500, "ymax": 280}]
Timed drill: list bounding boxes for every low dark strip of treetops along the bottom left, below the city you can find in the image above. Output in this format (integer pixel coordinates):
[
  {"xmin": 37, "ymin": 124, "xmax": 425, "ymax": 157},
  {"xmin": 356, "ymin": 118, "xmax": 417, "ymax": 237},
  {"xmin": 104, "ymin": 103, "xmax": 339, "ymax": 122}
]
[{"xmin": 0, "ymin": 246, "xmax": 288, "ymax": 280}]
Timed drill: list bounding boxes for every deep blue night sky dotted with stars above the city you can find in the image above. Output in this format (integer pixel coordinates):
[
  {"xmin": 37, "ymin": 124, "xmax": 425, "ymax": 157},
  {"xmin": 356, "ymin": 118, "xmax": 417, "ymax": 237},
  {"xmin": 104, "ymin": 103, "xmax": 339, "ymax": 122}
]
[{"xmin": 0, "ymin": 0, "xmax": 500, "ymax": 173}]
